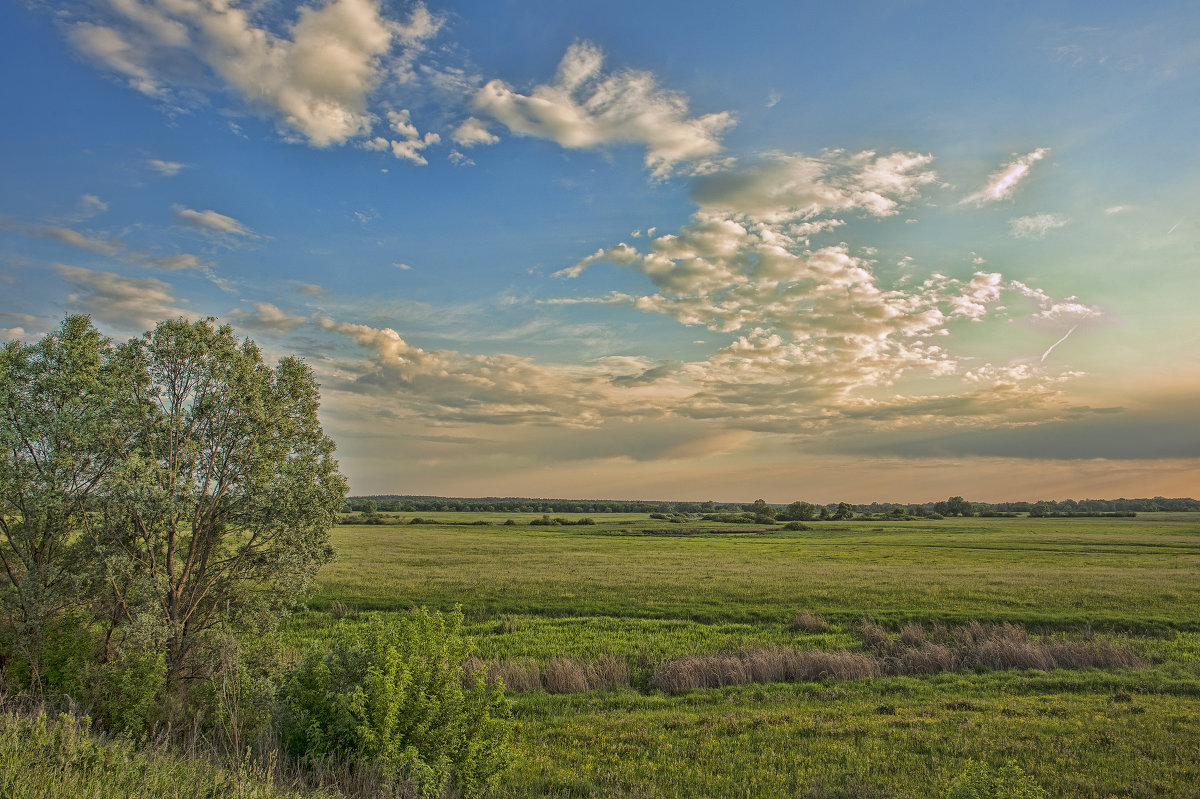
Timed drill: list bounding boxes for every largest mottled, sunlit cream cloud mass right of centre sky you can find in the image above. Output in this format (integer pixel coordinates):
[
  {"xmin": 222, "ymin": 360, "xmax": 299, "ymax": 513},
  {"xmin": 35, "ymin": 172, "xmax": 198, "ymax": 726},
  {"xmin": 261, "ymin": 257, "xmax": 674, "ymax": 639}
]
[{"xmin": 547, "ymin": 147, "xmax": 1100, "ymax": 431}]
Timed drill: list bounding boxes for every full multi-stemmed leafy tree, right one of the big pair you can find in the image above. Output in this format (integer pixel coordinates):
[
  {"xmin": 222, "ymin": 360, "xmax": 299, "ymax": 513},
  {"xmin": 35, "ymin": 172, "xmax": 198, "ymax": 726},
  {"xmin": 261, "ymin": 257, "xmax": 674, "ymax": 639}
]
[{"xmin": 94, "ymin": 319, "xmax": 347, "ymax": 686}]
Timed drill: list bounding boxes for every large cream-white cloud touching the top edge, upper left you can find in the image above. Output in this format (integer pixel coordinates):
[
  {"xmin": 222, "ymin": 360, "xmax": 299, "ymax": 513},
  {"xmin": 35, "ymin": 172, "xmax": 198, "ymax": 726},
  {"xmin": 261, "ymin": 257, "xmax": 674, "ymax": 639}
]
[{"xmin": 70, "ymin": 0, "xmax": 442, "ymax": 147}]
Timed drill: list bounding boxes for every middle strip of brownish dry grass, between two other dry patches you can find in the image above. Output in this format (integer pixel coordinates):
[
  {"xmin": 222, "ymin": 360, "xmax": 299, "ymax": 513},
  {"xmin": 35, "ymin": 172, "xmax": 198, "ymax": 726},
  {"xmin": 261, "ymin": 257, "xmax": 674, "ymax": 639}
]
[{"xmin": 650, "ymin": 647, "xmax": 881, "ymax": 693}]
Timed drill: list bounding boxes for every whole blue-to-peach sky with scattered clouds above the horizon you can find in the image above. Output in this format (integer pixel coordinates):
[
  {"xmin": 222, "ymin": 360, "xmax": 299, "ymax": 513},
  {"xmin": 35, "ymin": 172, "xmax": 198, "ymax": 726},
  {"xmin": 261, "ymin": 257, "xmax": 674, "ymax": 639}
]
[{"xmin": 0, "ymin": 0, "xmax": 1200, "ymax": 503}]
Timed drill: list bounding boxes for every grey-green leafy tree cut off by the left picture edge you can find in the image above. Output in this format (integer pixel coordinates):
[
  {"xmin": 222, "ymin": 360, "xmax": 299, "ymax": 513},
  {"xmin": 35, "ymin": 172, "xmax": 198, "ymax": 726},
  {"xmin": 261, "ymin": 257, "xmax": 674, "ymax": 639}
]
[{"xmin": 0, "ymin": 316, "xmax": 127, "ymax": 689}]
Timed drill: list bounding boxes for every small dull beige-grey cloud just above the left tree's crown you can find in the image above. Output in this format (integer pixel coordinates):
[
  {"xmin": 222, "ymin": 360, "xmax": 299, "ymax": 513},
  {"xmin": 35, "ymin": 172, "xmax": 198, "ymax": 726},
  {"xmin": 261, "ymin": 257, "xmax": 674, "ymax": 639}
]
[{"xmin": 55, "ymin": 264, "xmax": 194, "ymax": 332}]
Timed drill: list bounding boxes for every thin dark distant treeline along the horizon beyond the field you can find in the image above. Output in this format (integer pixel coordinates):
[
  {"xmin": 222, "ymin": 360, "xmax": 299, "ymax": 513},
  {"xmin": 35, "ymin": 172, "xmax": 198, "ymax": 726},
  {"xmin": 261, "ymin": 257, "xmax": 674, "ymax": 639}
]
[{"xmin": 344, "ymin": 494, "xmax": 1200, "ymax": 519}]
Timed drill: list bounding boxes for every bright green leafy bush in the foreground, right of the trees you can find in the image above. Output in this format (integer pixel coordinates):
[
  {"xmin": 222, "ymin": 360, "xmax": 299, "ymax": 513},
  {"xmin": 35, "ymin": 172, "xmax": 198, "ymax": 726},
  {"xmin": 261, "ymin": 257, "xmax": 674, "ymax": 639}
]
[{"xmin": 280, "ymin": 608, "xmax": 512, "ymax": 798}]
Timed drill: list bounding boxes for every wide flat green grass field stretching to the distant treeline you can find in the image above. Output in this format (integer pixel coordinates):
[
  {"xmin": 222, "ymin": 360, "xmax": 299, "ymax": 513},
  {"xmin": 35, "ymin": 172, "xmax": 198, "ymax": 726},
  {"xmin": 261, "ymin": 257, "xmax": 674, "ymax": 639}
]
[{"xmin": 288, "ymin": 513, "xmax": 1200, "ymax": 798}]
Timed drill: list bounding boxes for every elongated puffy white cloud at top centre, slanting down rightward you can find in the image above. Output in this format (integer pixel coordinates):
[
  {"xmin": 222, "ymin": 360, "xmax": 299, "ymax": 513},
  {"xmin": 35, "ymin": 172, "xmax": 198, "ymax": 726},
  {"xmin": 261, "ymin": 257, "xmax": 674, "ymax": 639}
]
[{"xmin": 472, "ymin": 42, "xmax": 733, "ymax": 179}]
